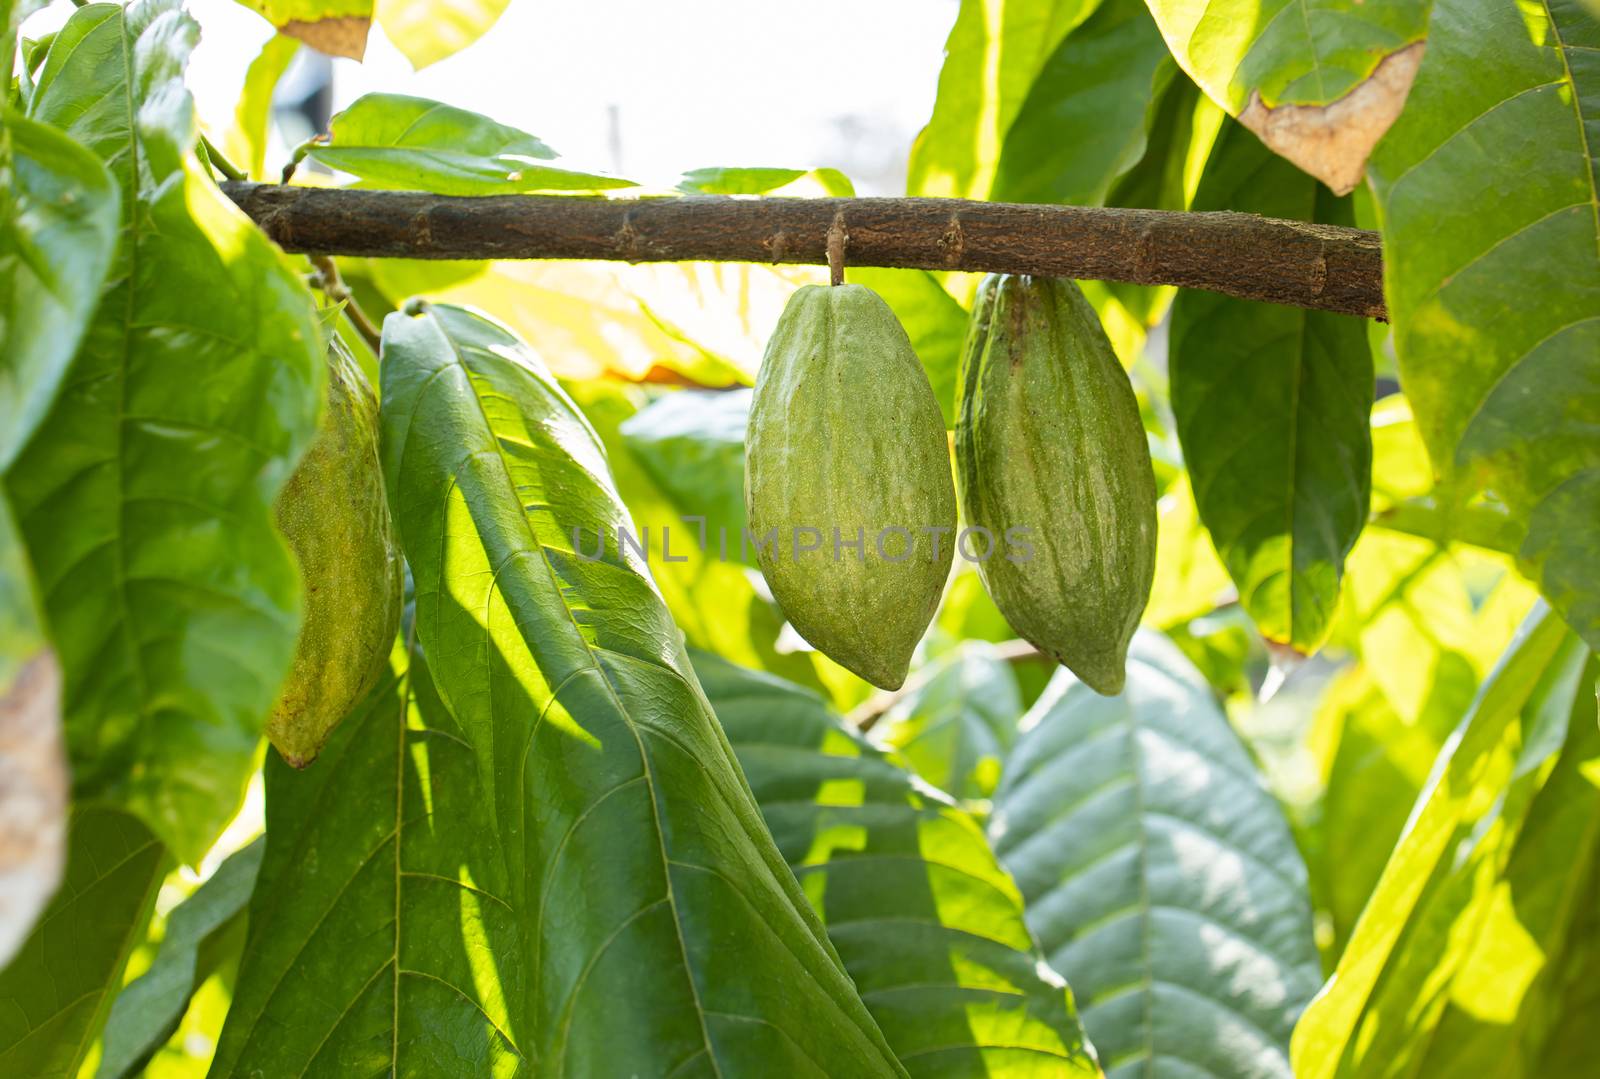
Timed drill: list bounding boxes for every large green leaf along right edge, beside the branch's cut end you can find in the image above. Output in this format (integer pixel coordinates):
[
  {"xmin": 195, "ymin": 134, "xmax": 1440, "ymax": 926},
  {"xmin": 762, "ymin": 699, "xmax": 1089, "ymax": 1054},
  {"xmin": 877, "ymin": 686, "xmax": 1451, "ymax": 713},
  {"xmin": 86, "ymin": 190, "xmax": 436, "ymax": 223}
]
[{"xmin": 1371, "ymin": 0, "xmax": 1600, "ymax": 647}]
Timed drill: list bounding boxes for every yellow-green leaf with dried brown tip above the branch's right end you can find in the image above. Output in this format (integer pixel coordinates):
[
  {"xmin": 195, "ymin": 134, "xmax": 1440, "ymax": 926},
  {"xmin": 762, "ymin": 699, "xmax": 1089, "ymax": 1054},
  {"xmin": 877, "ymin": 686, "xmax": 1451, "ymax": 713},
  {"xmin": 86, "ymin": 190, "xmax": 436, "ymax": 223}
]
[{"xmin": 1149, "ymin": 0, "xmax": 1433, "ymax": 195}]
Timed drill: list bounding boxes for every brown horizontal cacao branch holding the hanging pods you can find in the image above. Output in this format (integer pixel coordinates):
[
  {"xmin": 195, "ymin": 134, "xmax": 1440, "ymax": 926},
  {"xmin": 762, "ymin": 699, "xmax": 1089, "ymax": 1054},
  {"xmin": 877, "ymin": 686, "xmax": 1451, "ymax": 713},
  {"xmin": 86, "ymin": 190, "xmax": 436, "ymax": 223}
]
[{"xmin": 222, "ymin": 183, "xmax": 1386, "ymax": 319}]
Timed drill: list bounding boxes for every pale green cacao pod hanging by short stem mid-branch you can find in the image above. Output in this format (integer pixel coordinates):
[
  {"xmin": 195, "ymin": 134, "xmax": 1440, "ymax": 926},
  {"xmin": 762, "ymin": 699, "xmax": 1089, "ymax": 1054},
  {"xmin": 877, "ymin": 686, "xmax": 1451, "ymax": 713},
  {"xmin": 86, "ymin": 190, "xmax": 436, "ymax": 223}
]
[{"xmin": 744, "ymin": 285, "xmax": 955, "ymax": 688}]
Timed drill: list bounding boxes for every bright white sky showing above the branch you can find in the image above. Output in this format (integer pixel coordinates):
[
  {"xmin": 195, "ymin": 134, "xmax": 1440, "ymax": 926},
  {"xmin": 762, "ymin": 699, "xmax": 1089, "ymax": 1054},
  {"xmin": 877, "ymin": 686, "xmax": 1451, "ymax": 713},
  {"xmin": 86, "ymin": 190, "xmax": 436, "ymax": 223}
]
[{"xmin": 22, "ymin": 0, "xmax": 957, "ymax": 194}]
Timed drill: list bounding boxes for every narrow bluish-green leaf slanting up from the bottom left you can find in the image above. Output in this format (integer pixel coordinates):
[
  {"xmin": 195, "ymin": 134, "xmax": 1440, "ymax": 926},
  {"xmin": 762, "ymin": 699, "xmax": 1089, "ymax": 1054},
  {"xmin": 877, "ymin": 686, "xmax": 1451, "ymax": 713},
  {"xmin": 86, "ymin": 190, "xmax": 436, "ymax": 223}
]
[{"xmin": 94, "ymin": 839, "xmax": 266, "ymax": 1079}]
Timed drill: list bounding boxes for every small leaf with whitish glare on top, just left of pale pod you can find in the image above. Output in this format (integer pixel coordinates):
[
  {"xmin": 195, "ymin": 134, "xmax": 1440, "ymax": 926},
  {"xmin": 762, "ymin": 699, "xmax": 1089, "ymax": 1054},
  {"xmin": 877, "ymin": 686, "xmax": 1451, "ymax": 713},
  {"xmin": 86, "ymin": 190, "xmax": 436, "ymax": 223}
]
[{"xmin": 619, "ymin": 389, "xmax": 755, "ymax": 565}]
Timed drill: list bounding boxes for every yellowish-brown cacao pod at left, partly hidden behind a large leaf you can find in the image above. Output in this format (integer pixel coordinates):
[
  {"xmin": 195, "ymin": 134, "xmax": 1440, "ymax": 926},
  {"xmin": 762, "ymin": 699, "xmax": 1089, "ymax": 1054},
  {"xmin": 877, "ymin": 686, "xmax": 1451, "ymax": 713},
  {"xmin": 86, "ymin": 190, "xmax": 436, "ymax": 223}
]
[{"xmin": 267, "ymin": 335, "xmax": 403, "ymax": 768}]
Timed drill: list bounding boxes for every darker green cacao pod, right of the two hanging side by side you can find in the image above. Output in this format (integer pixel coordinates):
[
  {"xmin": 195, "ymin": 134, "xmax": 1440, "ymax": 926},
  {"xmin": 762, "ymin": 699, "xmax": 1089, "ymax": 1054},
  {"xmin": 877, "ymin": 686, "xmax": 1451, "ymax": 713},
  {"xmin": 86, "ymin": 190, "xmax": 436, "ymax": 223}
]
[{"xmin": 955, "ymin": 268, "xmax": 1155, "ymax": 695}]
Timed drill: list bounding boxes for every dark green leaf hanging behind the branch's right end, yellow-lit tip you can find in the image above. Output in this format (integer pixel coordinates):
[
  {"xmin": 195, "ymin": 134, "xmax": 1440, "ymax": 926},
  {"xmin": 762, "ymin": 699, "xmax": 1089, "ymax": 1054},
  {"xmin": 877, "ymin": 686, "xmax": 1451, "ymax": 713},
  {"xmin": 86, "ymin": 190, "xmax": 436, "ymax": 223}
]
[{"xmin": 1168, "ymin": 125, "xmax": 1373, "ymax": 653}]
